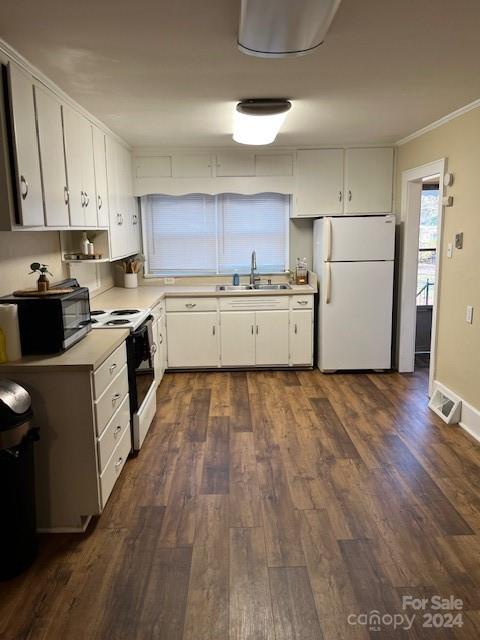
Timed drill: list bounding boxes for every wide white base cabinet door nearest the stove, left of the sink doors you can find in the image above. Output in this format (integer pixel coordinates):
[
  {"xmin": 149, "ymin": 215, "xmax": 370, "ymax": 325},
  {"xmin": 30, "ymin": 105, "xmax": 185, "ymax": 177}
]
[{"xmin": 167, "ymin": 311, "xmax": 219, "ymax": 367}]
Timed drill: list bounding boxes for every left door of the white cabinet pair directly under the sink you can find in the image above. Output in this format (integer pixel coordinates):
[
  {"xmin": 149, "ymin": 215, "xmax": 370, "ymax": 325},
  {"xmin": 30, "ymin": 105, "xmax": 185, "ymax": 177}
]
[{"xmin": 220, "ymin": 311, "xmax": 255, "ymax": 367}]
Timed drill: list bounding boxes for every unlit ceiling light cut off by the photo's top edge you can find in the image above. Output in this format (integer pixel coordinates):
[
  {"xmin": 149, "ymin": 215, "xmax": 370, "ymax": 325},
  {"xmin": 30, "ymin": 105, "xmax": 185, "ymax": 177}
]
[{"xmin": 238, "ymin": 0, "xmax": 341, "ymax": 58}]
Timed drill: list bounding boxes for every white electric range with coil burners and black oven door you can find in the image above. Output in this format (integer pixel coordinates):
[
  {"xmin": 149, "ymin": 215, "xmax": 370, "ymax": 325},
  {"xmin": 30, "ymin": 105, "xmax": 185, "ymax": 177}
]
[{"xmin": 90, "ymin": 309, "xmax": 157, "ymax": 451}]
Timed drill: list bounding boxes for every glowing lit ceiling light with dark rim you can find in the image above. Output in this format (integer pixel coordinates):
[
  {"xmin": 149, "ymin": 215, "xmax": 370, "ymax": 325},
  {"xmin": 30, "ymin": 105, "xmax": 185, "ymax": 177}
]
[{"xmin": 233, "ymin": 98, "xmax": 292, "ymax": 145}]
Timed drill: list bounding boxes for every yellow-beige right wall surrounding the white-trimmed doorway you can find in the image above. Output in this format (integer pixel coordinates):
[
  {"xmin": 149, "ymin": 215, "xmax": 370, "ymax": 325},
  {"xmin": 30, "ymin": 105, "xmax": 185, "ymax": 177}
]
[{"xmin": 396, "ymin": 109, "xmax": 480, "ymax": 409}]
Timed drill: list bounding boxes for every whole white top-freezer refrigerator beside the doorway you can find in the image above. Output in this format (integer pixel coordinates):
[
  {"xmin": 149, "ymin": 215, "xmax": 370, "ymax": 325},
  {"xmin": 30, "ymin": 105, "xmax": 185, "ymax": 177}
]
[{"xmin": 313, "ymin": 215, "xmax": 395, "ymax": 371}]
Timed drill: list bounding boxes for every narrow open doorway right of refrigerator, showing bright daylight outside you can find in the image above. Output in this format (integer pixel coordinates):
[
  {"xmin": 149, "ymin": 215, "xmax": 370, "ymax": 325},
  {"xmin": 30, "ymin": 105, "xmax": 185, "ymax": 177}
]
[{"xmin": 414, "ymin": 175, "xmax": 440, "ymax": 369}]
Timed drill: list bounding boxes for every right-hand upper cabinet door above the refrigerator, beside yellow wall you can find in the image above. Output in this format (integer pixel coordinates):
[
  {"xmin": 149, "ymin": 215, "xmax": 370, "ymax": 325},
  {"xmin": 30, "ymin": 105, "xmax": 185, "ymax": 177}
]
[{"xmin": 345, "ymin": 148, "xmax": 393, "ymax": 213}]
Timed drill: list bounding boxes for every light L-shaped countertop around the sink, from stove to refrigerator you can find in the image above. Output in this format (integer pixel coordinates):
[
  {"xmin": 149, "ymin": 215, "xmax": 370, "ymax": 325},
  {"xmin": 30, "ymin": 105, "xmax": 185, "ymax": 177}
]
[{"xmin": 90, "ymin": 284, "xmax": 316, "ymax": 309}]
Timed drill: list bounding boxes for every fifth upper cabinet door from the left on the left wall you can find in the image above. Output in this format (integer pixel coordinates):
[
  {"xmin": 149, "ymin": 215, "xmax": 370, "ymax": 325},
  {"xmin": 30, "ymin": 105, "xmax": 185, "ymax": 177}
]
[{"xmin": 106, "ymin": 136, "xmax": 125, "ymax": 259}]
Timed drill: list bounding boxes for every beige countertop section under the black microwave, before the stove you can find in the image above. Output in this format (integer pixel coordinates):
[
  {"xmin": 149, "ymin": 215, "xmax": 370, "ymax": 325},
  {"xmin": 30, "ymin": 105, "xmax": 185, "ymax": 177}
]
[{"xmin": 0, "ymin": 329, "xmax": 130, "ymax": 374}]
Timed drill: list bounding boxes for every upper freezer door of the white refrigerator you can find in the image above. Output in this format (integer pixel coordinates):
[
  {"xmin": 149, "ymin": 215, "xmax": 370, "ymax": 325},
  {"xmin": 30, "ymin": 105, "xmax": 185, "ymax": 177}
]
[{"xmin": 328, "ymin": 215, "xmax": 395, "ymax": 262}]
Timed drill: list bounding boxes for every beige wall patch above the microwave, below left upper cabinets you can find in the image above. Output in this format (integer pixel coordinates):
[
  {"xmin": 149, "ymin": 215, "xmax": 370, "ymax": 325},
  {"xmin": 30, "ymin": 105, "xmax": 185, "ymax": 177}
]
[{"xmin": 0, "ymin": 231, "xmax": 68, "ymax": 295}]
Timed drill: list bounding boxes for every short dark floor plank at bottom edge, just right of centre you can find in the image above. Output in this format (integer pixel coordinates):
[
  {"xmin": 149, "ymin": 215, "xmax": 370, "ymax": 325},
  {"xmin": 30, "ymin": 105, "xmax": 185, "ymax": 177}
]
[{"xmin": 268, "ymin": 567, "xmax": 324, "ymax": 640}]
